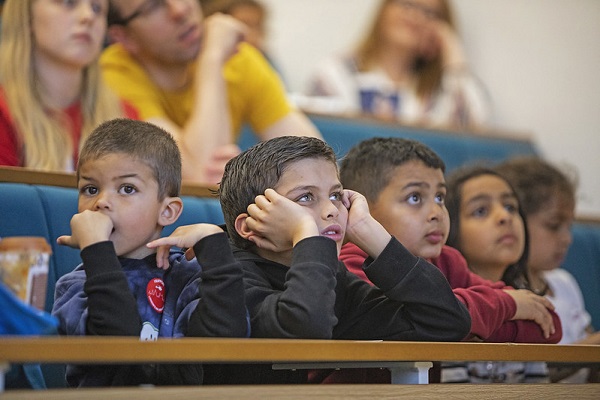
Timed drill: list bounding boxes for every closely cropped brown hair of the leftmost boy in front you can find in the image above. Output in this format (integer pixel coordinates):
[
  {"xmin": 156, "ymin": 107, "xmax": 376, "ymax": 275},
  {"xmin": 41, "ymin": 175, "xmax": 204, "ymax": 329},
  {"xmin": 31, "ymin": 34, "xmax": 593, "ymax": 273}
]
[{"xmin": 77, "ymin": 118, "xmax": 181, "ymax": 200}]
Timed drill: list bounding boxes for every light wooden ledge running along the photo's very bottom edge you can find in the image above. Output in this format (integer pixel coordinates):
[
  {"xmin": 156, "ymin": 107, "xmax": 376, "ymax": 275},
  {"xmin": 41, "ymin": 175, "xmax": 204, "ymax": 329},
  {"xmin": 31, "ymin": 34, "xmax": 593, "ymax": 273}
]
[{"xmin": 2, "ymin": 384, "xmax": 600, "ymax": 400}]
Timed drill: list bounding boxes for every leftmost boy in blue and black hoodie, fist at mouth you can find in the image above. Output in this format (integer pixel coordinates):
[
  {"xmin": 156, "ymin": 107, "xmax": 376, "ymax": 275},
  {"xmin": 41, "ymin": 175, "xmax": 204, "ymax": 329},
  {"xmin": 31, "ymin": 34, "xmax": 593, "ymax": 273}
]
[{"xmin": 52, "ymin": 119, "xmax": 249, "ymax": 386}]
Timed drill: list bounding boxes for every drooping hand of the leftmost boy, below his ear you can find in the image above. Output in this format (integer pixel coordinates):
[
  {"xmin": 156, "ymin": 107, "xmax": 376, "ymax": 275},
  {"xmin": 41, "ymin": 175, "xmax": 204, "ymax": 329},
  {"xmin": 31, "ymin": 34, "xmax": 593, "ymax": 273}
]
[{"xmin": 146, "ymin": 224, "xmax": 223, "ymax": 270}]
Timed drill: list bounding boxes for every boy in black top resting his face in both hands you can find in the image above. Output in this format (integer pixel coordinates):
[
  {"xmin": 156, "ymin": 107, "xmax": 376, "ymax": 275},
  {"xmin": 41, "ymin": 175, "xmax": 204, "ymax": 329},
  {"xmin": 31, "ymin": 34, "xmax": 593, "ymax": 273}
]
[{"xmin": 204, "ymin": 136, "xmax": 471, "ymax": 383}]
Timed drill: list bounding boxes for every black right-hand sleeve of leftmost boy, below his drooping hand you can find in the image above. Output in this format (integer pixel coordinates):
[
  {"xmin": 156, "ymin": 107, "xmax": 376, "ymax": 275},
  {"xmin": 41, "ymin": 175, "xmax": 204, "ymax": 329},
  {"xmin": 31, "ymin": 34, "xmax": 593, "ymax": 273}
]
[{"xmin": 186, "ymin": 233, "xmax": 250, "ymax": 337}]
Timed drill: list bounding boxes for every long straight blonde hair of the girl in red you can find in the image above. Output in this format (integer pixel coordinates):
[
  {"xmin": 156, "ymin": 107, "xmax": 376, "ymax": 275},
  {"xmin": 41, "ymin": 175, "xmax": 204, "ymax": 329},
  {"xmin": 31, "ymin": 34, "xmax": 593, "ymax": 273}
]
[{"xmin": 0, "ymin": 0, "xmax": 124, "ymax": 170}]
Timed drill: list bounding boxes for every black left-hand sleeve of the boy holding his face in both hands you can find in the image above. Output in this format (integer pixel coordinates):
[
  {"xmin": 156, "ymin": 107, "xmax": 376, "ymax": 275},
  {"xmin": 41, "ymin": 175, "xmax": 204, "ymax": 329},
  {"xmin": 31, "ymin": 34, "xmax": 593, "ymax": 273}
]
[{"xmin": 244, "ymin": 237, "xmax": 338, "ymax": 339}]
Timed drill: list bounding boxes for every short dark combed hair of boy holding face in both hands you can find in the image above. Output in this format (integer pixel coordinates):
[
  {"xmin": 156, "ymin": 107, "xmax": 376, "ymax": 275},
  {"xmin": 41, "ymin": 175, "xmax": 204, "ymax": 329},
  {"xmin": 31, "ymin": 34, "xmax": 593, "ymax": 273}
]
[{"xmin": 218, "ymin": 136, "xmax": 337, "ymax": 249}]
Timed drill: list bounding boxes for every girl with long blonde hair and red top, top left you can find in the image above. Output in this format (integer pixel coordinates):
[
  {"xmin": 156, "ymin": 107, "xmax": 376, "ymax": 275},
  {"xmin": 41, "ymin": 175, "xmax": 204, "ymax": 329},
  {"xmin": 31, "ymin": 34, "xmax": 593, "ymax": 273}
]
[{"xmin": 0, "ymin": 0, "xmax": 137, "ymax": 171}]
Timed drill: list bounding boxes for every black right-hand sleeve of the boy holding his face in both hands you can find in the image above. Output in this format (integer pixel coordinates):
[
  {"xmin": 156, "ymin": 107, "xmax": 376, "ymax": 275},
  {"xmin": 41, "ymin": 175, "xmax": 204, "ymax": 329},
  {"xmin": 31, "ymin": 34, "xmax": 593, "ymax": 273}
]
[{"xmin": 358, "ymin": 238, "xmax": 471, "ymax": 341}]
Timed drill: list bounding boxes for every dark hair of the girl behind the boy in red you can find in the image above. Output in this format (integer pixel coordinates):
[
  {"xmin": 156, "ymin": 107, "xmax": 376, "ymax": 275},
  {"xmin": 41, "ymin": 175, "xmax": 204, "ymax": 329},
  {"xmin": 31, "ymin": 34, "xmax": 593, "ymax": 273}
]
[{"xmin": 446, "ymin": 165, "xmax": 531, "ymax": 289}]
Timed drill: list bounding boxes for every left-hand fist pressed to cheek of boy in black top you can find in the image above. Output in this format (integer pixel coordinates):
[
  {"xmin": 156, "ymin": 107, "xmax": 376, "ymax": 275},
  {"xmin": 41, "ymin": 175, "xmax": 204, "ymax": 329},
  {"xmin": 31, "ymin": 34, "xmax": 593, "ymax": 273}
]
[{"xmin": 246, "ymin": 189, "xmax": 319, "ymax": 252}]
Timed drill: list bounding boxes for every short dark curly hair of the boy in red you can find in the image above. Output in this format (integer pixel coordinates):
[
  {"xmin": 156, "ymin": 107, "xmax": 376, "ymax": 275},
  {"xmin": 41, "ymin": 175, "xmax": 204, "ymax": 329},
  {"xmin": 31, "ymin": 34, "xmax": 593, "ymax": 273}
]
[{"xmin": 340, "ymin": 138, "xmax": 446, "ymax": 203}]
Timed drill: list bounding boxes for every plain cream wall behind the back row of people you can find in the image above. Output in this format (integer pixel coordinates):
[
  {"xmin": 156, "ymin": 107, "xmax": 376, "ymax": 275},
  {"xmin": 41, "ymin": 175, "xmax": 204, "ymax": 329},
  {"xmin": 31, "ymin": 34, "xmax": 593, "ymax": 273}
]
[{"xmin": 262, "ymin": 0, "xmax": 600, "ymax": 217}]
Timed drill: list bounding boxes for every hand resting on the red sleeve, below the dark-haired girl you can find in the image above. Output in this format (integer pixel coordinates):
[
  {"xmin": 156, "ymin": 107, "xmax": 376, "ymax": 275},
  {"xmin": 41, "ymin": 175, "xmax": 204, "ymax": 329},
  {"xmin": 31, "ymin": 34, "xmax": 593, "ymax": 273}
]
[{"xmin": 504, "ymin": 289, "xmax": 555, "ymax": 338}]
